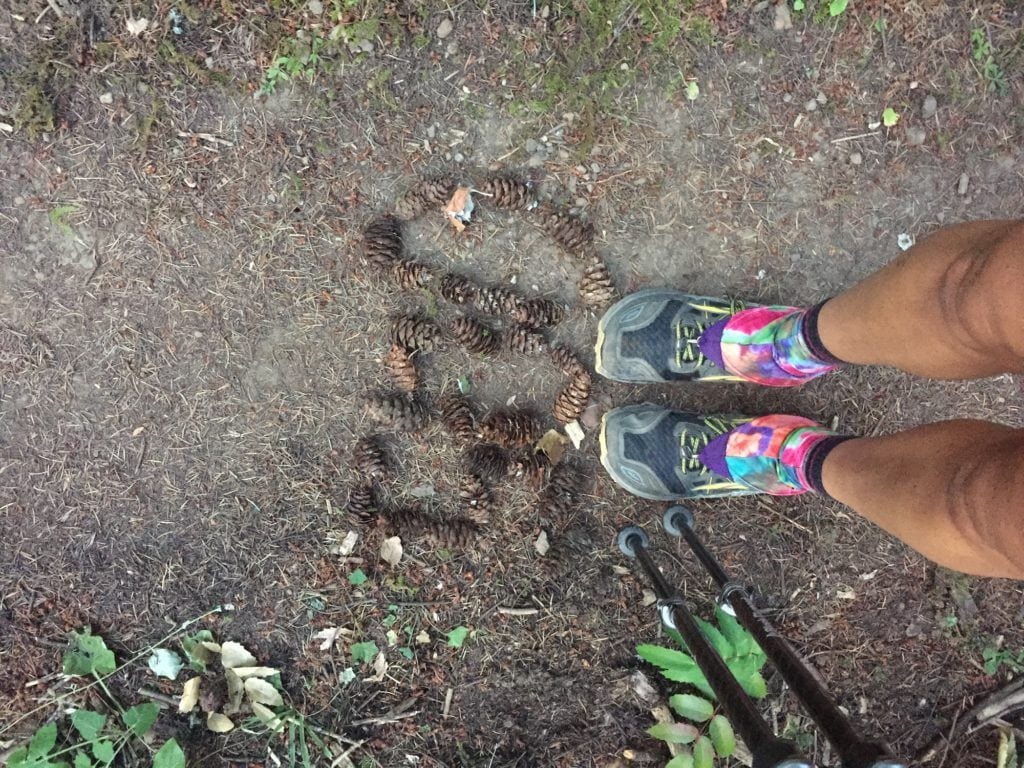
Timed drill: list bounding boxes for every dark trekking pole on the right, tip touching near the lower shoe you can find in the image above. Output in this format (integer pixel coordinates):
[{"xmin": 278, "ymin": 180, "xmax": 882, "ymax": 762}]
[{"xmin": 662, "ymin": 506, "xmax": 906, "ymax": 768}]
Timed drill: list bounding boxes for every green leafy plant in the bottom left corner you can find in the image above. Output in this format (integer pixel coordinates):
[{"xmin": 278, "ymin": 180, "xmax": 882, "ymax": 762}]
[{"xmin": 7, "ymin": 627, "xmax": 185, "ymax": 768}]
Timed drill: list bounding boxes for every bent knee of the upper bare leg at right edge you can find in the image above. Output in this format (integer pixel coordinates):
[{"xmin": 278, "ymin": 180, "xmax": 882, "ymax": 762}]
[{"xmin": 938, "ymin": 221, "xmax": 1024, "ymax": 371}]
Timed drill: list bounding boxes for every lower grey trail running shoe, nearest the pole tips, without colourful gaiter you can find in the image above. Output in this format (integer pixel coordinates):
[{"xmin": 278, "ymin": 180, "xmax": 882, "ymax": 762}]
[{"xmin": 601, "ymin": 402, "xmax": 758, "ymax": 501}]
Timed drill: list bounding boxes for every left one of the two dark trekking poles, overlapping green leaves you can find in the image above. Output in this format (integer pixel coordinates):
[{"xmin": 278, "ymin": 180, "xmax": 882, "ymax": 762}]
[{"xmin": 618, "ymin": 525, "xmax": 814, "ymax": 768}]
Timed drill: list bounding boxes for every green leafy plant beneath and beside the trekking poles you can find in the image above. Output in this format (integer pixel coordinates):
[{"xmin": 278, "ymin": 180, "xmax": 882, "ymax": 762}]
[{"xmin": 637, "ymin": 608, "xmax": 767, "ymax": 768}]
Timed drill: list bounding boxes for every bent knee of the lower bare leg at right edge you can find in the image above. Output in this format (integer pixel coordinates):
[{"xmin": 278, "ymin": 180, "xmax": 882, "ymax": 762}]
[{"xmin": 945, "ymin": 429, "xmax": 1024, "ymax": 579}]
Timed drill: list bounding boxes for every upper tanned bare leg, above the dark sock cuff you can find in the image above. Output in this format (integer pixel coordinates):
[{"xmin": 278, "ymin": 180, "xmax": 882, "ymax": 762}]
[{"xmin": 818, "ymin": 221, "xmax": 1024, "ymax": 379}]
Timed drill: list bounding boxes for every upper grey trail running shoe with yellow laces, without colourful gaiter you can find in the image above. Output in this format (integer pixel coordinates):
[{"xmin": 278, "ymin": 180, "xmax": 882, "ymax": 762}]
[{"xmin": 594, "ymin": 288, "xmax": 755, "ymax": 384}]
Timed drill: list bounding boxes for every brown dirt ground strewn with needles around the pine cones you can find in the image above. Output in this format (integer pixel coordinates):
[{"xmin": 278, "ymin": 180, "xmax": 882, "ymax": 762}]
[{"xmin": 0, "ymin": 0, "xmax": 1024, "ymax": 766}]
